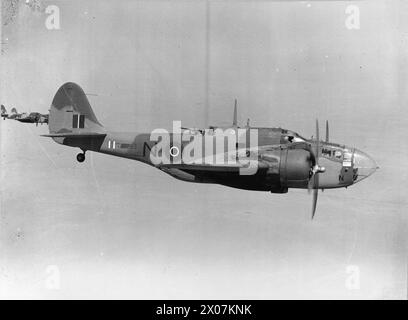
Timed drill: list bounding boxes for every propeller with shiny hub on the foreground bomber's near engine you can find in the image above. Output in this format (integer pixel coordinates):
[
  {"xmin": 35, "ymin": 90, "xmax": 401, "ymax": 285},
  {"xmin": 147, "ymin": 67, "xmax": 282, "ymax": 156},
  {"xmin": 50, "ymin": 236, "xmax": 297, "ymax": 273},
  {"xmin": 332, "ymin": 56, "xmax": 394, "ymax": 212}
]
[{"xmin": 307, "ymin": 119, "xmax": 328, "ymax": 219}]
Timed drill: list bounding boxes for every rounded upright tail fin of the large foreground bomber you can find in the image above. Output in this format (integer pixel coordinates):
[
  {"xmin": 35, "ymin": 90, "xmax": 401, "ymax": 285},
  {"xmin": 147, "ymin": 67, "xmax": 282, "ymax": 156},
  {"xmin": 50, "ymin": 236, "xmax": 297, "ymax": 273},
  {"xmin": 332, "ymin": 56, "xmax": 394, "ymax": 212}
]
[{"xmin": 48, "ymin": 82, "xmax": 105, "ymax": 134}]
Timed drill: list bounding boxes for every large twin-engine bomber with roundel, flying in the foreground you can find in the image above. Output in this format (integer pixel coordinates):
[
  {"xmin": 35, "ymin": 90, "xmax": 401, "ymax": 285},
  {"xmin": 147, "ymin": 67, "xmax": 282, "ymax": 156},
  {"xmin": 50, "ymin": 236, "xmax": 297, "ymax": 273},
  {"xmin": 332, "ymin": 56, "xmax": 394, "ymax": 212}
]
[{"xmin": 44, "ymin": 83, "xmax": 378, "ymax": 218}]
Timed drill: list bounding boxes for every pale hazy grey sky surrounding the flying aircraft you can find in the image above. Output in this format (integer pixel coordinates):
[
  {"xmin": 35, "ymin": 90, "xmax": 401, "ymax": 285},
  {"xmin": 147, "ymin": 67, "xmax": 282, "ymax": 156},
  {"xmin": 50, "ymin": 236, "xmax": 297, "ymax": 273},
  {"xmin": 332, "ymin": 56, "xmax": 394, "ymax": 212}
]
[{"xmin": 0, "ymin": 0, "xmax": 408, "ymax": 299}]
